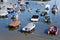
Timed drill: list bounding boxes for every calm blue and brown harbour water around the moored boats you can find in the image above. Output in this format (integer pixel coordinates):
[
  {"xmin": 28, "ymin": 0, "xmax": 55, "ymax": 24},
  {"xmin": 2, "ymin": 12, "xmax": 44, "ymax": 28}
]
[{"xmin": 0, "ymin": 0, "xmax": 60, "ymax": 40}]
